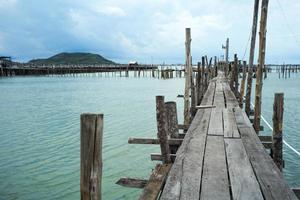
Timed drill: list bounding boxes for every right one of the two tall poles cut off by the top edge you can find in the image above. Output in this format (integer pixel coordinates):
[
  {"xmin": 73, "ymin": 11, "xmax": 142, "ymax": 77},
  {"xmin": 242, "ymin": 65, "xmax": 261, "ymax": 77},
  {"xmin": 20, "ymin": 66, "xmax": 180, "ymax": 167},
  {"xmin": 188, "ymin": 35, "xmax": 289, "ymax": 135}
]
[{"xmin": 253, "ymin": 0, "xmax": 269, "ymax": 133}]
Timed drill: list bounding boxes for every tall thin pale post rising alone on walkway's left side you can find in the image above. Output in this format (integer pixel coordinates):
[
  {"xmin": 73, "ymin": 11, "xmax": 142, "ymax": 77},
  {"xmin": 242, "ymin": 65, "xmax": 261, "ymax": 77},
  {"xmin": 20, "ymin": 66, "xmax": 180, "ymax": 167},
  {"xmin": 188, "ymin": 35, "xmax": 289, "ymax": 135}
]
[{"xmin": 184, "ymin": 28, "xmax": 191, "ymax": 125}]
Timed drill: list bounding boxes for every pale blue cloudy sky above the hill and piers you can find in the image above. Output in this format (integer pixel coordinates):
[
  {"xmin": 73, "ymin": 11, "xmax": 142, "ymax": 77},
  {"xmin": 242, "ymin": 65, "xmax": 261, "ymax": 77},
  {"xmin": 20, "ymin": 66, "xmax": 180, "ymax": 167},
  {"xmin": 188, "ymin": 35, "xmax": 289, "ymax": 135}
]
[{"xmin": 0, "ymin": 0, "xmax": 300, "ymax": 64}]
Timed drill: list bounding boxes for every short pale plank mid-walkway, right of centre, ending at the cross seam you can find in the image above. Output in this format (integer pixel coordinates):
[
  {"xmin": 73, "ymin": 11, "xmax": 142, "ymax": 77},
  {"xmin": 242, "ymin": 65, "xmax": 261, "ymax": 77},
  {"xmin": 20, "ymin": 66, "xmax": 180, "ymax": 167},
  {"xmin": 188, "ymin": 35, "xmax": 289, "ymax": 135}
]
[{"xmin": 223, "ymin": 108, "xmax": 240, "ymax": 138}]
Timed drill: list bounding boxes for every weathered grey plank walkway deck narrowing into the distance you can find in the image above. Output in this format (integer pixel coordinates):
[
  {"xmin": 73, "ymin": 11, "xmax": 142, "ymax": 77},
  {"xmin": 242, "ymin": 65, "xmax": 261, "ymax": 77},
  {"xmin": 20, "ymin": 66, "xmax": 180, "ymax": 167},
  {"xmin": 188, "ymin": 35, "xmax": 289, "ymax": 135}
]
[{"xmin": 160, "ymin": 74, "xmax": 297, "ymax": 200}]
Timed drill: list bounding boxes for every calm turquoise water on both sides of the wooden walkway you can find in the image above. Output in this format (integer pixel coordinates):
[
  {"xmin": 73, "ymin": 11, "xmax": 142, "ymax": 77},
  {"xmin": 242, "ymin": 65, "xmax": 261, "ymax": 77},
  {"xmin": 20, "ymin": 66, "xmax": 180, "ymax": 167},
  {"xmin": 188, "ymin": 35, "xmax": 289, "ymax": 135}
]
[{"xmin": 0, "ymin": 73, "xmax": 300, "ymax": 200}]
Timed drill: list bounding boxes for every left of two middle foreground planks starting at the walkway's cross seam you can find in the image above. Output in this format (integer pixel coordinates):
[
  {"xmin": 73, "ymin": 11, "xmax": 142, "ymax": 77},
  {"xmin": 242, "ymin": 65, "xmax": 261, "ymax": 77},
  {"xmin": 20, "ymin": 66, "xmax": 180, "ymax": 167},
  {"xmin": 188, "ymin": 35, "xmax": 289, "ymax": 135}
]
[{"xmin": 200, "ymin": 135, "xmax": 230, "ymax": 200}]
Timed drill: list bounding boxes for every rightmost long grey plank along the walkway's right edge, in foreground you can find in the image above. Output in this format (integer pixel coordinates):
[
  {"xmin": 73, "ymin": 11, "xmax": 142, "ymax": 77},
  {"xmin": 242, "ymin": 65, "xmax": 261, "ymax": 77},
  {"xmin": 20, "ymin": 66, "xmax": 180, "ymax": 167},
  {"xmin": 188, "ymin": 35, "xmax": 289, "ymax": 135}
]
[{"xmin": 235, "ymin": 109, "xmax": 297, "ymax": 200}]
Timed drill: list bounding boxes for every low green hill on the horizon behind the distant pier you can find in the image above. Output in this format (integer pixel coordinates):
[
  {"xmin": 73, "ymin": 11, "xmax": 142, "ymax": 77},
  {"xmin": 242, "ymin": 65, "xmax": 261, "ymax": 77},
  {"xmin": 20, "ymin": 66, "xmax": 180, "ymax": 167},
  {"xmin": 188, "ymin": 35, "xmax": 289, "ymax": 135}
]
[{"xmin": 28, "ymin": 53, "xmax": 114, "ymax": 65}]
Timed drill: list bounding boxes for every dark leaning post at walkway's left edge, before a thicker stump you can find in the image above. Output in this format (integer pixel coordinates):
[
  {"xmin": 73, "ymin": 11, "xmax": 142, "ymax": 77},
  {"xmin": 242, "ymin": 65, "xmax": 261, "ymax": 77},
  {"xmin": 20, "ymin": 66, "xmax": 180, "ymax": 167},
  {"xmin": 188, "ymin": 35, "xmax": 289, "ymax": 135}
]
[{"xmin": 156, "ymin": 96, "xmax": 171, "ymax": 164}]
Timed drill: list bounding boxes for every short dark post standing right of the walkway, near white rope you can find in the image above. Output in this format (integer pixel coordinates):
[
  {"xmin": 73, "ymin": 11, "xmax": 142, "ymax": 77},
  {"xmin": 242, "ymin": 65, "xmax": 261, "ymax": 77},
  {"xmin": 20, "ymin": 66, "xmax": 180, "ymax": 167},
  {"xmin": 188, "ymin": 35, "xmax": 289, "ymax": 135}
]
[{"xmin": 272, "ymin": 93, "xmax": 284, "ymax": 171}]
